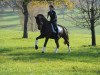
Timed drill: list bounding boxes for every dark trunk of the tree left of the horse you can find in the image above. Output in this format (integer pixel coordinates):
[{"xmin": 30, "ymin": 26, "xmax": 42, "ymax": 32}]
[{"xmin": 22, "ymin": 2, "xmax": 28, "ymax": 38}]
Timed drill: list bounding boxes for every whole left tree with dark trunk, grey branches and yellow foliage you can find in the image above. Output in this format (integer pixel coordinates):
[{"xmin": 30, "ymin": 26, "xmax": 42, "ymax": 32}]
[{"xmin": 0, "ymin": 0, "xmax": 72, "ymax": 38}]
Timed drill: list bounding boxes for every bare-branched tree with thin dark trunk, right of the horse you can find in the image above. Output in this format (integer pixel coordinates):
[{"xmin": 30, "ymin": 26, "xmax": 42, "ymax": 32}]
[{"xmin": 72, "ymin": 0, "xmax": 100, "ymax": 46}]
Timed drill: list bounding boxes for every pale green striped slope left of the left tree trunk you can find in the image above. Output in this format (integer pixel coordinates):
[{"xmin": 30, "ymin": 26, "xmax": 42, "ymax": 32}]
[{"xmin": 0, "ymin": 11, "xmax": 21, "ymax": 30}]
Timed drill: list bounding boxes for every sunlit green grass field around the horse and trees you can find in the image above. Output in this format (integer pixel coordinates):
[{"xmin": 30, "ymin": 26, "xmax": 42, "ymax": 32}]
[{"xmin": 0, "ymin": 12, "xmax": 100, "ymax": 75}]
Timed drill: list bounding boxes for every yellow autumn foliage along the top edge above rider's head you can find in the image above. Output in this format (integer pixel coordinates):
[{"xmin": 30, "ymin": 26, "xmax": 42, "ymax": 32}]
[{"xmin": 28, "ymin": 0, "xmax": 74, "ymax": 9}]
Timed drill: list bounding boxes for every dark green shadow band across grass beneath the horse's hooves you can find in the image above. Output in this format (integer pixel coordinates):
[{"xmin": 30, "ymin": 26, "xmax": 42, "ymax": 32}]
[{"xmin": 6, "ymin": 47, "xmax": 100, "ymax": 62}]
